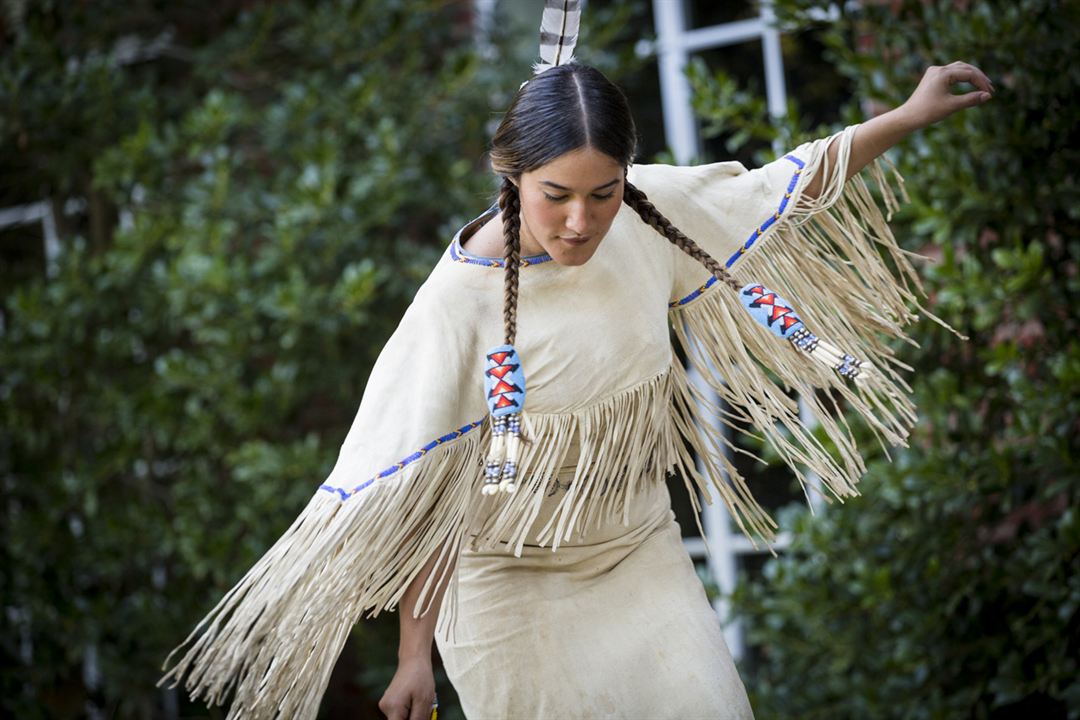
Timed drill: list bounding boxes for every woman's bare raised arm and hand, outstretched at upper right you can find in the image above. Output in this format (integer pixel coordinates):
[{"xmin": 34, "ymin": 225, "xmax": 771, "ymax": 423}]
[{"xmin": 802, "ymin": 62, "xmax": 994, "ymax": 198}]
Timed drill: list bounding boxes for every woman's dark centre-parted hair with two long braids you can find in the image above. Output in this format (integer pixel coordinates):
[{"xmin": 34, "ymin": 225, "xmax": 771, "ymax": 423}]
[{"xmin": 490, "ymin": 63, "xmax": 741, "ymax": 344}]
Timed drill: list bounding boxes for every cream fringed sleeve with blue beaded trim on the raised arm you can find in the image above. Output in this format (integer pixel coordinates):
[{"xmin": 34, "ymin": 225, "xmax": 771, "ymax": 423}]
[{"xmin": 632, "ymin": 126, "xmax": 940, "ymax": 544}]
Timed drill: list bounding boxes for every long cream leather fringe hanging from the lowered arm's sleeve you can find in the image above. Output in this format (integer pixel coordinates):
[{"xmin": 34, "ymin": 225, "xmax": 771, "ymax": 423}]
[{"xmin": 158, "ymin": 433, "xmax": 485, "ymax": 720}]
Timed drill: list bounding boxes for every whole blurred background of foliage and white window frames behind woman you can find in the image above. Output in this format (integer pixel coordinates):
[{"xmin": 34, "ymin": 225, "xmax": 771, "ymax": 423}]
[{"xmin": 0, "ymin": 0, "xmax": 1080, "ymax": 720}]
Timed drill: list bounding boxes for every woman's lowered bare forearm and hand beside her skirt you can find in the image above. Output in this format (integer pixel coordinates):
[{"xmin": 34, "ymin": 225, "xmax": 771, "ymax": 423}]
[{"xmin": 379, "ymin": 552, "xmax": 457, "ymax": 720}]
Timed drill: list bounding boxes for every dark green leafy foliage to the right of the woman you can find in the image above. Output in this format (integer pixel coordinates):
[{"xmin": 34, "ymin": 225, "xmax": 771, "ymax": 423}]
[{"xmin": 696, "ymin": 0, "xmax": 1080, "ymax": 718}]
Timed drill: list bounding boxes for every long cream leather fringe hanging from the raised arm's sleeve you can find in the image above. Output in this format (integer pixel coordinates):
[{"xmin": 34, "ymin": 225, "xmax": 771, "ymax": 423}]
[{"xmin": 672, "ymin": 136, "xmax": 963, "ymax": 551}]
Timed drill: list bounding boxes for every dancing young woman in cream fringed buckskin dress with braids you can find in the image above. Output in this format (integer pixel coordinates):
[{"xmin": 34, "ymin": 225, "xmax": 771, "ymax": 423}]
[{"xmin": 156, "ymin": 49, "xmax": 993, "ymax": 720}]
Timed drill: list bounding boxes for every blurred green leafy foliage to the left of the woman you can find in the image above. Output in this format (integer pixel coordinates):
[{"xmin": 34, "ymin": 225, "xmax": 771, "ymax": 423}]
[{"xmin": 0, "ymin": 0, "xmax": 521, "ymax": 718}]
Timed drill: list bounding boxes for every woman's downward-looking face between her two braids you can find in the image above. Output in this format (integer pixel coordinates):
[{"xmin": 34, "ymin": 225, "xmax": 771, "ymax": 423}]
[{"xmin": 514, "ymin": 148, "xmax": 625, "ymax": 266}]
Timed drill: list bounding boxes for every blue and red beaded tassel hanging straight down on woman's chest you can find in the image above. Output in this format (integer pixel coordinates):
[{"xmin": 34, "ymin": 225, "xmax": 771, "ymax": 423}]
[{"xmin": 482, "ymin": 344, "xmax": 525, "ymax": 495}]
